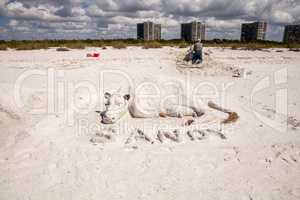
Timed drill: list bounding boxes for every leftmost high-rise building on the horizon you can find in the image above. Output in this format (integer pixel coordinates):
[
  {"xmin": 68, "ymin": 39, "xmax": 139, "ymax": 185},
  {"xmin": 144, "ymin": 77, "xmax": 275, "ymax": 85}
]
[{"xmin": 137, "ymin": 21, "xmax": 161, "ymax": 41}]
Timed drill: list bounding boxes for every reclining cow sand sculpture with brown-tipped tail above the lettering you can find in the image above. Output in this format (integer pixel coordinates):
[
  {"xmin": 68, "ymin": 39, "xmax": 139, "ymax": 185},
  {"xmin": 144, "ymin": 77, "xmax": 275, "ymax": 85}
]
[{"xmin": 99, "ymin": 88, "xmax": 239, "ymax": 124}]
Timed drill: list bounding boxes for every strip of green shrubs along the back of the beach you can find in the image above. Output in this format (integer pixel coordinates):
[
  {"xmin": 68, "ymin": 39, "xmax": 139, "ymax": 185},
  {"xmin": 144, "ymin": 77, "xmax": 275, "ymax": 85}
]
[{"xmin": 0, "ymin": 39, "xmax": 300, "ymax": 50}]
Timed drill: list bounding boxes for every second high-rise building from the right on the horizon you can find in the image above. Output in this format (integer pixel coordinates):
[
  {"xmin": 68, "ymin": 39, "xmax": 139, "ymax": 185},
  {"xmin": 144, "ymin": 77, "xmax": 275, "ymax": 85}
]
[{"xmin": 241, "ymin": 22, "xmax": 267, "ymax": 42}]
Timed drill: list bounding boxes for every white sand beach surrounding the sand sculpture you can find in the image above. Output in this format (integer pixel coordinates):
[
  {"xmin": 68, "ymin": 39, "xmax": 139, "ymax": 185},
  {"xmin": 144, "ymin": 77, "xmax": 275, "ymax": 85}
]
[{"xmin": 0, "ymin": 47, "xmax": 300, "ymax": 200}]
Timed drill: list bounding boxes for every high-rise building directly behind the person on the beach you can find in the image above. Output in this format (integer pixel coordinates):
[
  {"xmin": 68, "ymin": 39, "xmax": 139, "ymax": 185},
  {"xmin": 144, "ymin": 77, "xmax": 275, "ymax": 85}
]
[{"xmin": 181, "ymin": 21, "xmax": 205, "ymax": 41}]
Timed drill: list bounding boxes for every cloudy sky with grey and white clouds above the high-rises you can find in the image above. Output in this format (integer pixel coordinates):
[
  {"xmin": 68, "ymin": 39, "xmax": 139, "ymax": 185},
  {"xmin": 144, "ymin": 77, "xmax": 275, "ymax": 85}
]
[{"xmin": 0, "ymin": 0, "xmax": 300, "ymax": 40}]
